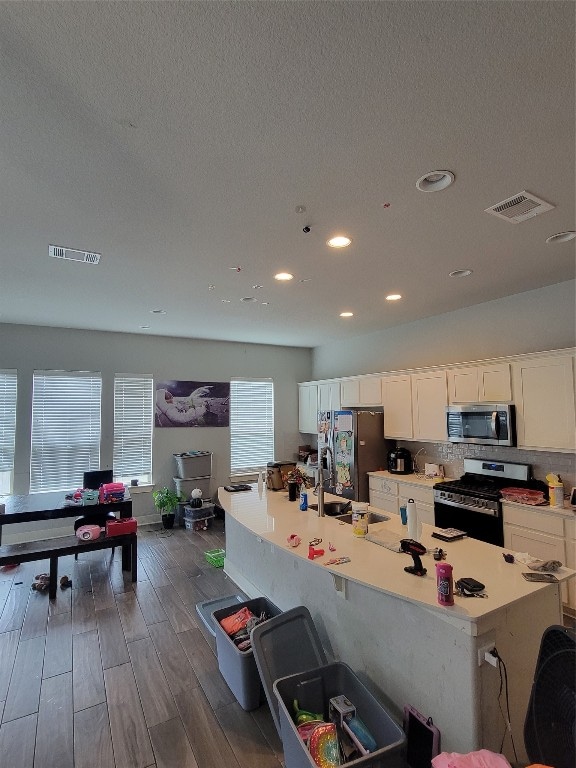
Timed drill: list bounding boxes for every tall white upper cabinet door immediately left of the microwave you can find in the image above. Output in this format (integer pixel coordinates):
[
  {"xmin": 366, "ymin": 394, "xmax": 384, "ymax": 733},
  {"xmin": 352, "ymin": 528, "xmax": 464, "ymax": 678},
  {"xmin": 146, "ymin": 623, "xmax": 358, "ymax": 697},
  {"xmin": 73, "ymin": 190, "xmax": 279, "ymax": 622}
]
[{"xmin": 412, "ymin": 371, "xmax": 448, "ymax": 440}]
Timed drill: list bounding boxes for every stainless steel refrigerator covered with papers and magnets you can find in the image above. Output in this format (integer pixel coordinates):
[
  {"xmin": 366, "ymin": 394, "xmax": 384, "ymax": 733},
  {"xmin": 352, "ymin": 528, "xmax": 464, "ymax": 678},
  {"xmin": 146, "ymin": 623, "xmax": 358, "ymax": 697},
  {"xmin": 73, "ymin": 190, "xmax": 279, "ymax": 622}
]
[{"xmin": 318, "ymin": 411, "xmax": 389, "ymax": 501}]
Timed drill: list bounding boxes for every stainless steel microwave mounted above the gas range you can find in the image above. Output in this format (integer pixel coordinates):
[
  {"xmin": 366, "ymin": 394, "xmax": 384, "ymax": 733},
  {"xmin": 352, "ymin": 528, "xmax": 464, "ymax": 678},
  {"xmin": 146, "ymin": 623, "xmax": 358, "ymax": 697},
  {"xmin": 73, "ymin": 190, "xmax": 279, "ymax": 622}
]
[{"xmin": 446, "ymin": 403, "xmax": 516, "ymax": 445}]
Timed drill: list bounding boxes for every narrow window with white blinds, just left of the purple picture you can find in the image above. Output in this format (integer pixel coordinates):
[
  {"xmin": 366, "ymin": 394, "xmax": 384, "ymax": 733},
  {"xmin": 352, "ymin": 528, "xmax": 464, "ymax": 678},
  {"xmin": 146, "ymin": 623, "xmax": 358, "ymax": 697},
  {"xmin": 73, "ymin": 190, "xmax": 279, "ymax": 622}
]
[{"xmin": 114, "ymin": 376, "xmax": 154, "ymax": 483}]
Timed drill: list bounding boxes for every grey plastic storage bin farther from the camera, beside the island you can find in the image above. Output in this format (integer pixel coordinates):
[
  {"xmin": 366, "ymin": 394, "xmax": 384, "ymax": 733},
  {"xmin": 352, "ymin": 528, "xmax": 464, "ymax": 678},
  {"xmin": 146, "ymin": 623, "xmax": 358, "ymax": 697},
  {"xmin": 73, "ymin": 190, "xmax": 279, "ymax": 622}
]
[{"xmin": 212, "ymin": 597, "xmax": 280, "ymax": 711}]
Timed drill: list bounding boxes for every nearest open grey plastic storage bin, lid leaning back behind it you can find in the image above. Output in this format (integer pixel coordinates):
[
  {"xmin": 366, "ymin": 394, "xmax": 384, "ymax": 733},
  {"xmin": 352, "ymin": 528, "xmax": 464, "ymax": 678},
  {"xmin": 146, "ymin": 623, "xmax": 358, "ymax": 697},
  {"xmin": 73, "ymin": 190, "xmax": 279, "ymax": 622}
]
[{"xmin": 252, "ymin": 606, "xmax": 406, "ymax": 768}]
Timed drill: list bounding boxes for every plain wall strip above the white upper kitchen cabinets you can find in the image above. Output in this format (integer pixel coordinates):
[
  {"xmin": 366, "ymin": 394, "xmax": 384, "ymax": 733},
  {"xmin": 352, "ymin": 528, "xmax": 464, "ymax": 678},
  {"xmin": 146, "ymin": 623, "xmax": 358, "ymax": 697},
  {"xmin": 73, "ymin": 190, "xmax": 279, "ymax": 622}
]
[{"xmin": 312, "ymin": 280, "xmax": 576, "ymax": 379}]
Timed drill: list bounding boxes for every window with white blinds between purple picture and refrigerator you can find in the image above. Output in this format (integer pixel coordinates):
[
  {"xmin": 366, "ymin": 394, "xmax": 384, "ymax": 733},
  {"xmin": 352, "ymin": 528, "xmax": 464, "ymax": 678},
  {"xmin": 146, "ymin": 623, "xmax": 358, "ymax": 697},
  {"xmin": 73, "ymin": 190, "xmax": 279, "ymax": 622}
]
[{"xmin": 230, "ymin": 379, "xmax": 274, "ymax": 475}]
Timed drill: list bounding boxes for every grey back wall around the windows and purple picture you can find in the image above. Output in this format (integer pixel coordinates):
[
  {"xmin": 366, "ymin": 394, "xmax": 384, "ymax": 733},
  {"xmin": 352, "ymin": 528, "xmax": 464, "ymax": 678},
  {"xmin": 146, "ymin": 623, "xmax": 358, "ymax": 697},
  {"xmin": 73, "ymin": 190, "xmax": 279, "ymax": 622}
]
[{"xmin": 0, "ymin": 326, "xmax": 312, "ymax": 493}]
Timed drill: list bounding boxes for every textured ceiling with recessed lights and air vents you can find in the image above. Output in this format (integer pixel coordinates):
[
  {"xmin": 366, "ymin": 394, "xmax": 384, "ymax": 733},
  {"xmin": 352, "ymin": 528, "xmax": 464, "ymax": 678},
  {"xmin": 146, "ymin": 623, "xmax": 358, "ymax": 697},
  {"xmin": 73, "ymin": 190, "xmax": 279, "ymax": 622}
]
[{"xmin": 0, "ymin": 0, "xmax": 576, "ymax": 346}]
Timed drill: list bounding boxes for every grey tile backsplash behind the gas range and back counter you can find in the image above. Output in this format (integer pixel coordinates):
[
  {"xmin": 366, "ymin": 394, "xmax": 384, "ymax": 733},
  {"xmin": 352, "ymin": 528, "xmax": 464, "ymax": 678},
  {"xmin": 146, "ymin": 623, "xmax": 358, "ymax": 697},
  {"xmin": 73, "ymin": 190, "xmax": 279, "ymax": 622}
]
[{"xmin": 398, "ymin": 441, "xmax": 576, "ymax": 494}]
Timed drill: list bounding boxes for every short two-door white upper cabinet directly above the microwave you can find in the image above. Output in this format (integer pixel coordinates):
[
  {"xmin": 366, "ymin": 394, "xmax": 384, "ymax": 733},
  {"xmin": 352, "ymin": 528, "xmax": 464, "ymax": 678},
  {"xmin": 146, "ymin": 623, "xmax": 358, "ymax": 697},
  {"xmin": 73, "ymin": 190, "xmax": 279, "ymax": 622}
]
[{"xmin": 448, "ymin": 363, "xmax": 512, "ymax": 403}]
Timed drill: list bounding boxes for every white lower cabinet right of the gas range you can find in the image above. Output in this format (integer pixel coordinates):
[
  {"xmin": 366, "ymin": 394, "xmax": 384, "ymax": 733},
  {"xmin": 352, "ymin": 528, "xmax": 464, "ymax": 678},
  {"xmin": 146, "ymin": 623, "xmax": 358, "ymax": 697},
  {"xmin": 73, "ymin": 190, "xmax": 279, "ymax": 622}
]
[{"xmin": 502, "ymin": 503, "xmax": 576, "ymax": 609}]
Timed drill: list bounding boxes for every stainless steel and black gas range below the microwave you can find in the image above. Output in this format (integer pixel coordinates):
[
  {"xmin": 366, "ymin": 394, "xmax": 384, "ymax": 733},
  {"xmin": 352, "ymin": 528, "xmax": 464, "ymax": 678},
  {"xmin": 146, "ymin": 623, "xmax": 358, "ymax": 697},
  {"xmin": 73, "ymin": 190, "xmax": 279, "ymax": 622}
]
[{"xmin": 434, "ymin": 459, "xmax": 546, "ymax": 547}]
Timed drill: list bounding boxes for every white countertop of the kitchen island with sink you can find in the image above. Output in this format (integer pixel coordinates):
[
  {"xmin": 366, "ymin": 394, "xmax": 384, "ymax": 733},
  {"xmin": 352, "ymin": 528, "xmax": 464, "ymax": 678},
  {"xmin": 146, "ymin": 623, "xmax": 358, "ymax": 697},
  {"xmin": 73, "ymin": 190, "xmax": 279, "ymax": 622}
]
[{"xmin": 218, "ymin": 488, "xmax": 576, "ymax": 622}]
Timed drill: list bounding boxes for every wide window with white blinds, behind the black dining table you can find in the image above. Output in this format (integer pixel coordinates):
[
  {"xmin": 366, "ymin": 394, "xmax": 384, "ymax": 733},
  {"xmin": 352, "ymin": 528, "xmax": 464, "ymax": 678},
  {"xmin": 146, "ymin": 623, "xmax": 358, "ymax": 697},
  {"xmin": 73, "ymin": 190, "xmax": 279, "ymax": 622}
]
[{"xmin": 30, "ymin": 371, "xmax": 102, "ymax": 493}]
